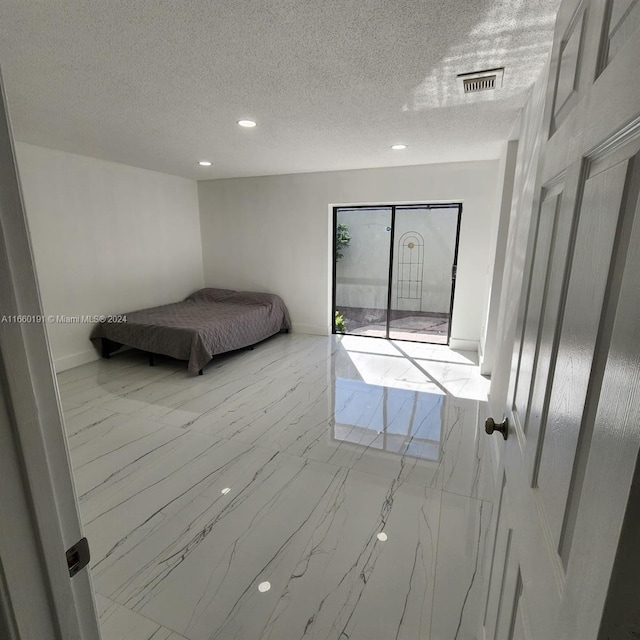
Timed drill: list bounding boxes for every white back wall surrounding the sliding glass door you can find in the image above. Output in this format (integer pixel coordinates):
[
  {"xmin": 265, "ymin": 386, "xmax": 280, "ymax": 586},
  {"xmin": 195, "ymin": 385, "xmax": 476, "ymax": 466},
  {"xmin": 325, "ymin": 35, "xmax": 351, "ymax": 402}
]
[{"xmin": 198, "ymin": 160, "xmax": 499, "ymax": 348}]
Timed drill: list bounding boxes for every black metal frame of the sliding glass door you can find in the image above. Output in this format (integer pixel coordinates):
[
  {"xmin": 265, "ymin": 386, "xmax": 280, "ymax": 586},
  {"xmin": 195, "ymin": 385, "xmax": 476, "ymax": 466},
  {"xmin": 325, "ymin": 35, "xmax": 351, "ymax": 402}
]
[{"xmin": 331, "ymin": 202, "xmax": 462, "ymax": 345}]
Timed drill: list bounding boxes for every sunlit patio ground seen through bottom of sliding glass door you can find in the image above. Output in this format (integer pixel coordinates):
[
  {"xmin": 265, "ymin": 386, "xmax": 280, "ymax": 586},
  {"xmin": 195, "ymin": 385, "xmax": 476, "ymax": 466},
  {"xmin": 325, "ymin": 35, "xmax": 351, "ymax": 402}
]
[{"xmin": 339, "ymin": 307, "xmax": 449, "ymax": 344}]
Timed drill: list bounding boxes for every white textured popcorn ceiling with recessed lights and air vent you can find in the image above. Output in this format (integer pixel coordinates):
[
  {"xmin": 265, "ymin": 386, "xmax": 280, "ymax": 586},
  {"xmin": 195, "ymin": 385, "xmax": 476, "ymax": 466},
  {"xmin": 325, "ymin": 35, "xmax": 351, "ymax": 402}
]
[{"xmin": 0, "ymin": 0, "xmax": 559, "ymax": 179}]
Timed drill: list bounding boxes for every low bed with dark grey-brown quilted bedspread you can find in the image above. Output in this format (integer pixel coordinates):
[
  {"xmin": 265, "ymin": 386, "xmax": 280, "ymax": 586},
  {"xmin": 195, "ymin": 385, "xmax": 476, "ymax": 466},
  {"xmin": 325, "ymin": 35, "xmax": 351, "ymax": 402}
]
[{"xmin": 90, "ymin": 288, "xmax": 291, "ymax": 375}]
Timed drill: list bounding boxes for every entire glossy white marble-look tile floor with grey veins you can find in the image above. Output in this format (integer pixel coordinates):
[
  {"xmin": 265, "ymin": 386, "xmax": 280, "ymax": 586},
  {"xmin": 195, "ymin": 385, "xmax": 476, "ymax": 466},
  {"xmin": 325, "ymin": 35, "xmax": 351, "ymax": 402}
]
[{"xmin": 59, "ymin": 335, "xmax": 493, "ymax": 640}]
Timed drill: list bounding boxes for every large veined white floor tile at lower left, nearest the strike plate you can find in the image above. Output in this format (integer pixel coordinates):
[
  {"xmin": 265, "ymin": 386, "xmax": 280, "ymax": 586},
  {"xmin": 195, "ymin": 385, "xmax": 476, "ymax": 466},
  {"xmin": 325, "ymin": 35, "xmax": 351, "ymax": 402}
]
[{"xmin": 100, "ymin": 449, "xmax": 347, "ymax": 640}]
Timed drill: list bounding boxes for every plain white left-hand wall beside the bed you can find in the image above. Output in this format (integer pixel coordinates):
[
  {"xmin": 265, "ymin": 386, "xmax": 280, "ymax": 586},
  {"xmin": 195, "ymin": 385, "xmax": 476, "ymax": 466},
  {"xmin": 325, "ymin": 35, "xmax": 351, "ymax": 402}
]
[{"xmin": 16, "ymin": 143, "xmax": 203, "ymax": 371}]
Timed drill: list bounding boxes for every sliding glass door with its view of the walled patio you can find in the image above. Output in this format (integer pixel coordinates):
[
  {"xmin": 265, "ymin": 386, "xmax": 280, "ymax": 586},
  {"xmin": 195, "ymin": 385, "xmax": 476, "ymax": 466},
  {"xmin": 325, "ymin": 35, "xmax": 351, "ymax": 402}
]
[{"xmin": 334, "ymin": 203, "xmax": 462, "ymax": 344}]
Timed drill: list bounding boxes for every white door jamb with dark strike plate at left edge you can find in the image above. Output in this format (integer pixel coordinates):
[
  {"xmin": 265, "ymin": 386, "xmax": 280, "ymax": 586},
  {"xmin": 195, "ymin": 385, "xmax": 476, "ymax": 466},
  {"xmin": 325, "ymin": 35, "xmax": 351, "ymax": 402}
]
[{"xmin": 0, "ymin": 69, "xmax": 100, "ymax": 640}]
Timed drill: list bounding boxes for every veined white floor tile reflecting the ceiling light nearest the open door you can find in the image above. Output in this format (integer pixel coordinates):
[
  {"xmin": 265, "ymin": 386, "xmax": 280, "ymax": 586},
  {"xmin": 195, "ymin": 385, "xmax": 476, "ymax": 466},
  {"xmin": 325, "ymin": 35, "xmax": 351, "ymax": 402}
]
[{"xmin": 260, "ymin": 471, "xmax": 440, "ymax": 640}]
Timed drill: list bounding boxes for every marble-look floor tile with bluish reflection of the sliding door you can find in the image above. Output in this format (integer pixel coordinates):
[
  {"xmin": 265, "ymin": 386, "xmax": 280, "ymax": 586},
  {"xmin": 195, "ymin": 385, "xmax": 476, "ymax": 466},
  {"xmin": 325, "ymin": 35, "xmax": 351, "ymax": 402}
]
[{"xmin": 182, "ymin": 370, "xmax": 484, "ymax": 497}]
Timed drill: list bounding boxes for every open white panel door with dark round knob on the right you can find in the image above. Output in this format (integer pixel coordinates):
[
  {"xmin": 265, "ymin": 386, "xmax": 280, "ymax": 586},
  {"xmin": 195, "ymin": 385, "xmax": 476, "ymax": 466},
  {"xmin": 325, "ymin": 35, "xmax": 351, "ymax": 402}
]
[{"xmin": 483, "ymin": 0, "xmax": 640, "ymax": 640}]
